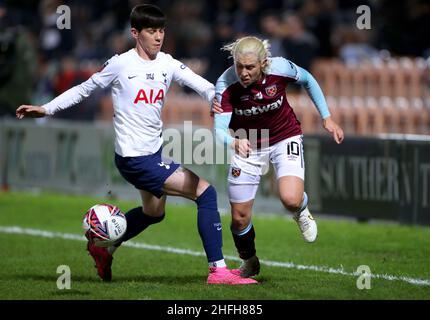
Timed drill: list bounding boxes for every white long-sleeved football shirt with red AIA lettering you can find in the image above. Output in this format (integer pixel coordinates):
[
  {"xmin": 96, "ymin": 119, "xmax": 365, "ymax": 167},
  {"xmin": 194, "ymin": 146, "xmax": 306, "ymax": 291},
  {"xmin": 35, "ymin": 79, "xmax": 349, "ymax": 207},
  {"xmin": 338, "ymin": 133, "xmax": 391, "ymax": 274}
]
[{"xmin": 43, "ymin": 49, "xmax": 215, "ymax": 157}]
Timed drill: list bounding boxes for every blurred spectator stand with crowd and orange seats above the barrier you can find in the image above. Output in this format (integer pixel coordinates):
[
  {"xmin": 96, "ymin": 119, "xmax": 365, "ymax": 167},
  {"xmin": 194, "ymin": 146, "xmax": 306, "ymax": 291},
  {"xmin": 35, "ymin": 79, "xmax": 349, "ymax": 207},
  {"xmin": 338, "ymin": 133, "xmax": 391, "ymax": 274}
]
[{"xmin": 0, "ymin": 0, "xmax": 430, "ymax": 124}]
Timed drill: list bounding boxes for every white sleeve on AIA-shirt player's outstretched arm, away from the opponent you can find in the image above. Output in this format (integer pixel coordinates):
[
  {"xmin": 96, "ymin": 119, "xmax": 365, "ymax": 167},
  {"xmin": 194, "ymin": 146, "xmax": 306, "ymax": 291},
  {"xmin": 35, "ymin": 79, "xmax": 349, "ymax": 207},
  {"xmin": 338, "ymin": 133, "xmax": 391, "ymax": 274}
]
[{"xmin": 42, "ymin": 55, "xmax": 119, "ymax": 115}]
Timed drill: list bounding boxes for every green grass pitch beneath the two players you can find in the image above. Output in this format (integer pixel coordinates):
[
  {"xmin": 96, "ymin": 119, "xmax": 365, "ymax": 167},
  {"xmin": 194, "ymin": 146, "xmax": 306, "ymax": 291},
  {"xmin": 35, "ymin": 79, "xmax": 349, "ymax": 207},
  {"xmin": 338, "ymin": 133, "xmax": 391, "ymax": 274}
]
[{"xmin": 0, "ymin": 193, "xmax": 430, "ymax": 300}]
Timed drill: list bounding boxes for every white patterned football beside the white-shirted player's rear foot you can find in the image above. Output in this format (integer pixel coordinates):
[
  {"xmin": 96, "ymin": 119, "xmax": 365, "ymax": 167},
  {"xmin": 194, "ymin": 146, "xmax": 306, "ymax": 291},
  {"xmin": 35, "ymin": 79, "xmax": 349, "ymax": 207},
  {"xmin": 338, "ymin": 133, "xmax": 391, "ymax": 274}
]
[{"xmin": 83, "ymin": 204, "xmax": 127, "ymax": 247}]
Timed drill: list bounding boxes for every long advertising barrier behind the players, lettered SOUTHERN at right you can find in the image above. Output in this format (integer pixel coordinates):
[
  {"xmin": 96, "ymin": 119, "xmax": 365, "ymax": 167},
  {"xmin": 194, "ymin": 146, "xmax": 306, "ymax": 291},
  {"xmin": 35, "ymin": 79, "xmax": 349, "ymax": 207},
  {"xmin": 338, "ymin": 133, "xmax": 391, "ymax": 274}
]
[{"xmin": 0, "ymin": 120, "xmax": 430, "ymax": 225}]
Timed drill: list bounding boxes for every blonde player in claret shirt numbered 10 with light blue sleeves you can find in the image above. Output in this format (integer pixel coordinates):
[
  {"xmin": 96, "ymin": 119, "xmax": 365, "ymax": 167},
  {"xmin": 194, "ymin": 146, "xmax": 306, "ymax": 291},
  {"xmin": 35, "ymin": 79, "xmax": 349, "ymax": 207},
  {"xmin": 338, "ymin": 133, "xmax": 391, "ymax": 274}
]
[{"xmin": 214, "ymin": 37, "xmax": 344, "ymax": 277}]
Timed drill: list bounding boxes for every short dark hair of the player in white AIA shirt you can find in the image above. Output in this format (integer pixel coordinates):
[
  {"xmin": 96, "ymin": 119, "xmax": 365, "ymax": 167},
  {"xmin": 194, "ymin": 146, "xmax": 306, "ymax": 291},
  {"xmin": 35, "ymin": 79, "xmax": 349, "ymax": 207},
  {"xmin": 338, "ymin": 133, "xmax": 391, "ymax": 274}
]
[{"xmin": 130, "ymin": 4, "xmax": 166, "ymax": 32}]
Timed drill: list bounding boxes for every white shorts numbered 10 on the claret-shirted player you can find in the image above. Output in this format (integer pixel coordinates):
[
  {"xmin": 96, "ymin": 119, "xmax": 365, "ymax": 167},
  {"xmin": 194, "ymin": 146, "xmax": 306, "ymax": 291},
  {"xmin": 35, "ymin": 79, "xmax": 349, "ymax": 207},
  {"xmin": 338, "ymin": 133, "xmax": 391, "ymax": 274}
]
[{"xmin": 228, "ymin": 135, "xmax": 305, "ymax": 203}]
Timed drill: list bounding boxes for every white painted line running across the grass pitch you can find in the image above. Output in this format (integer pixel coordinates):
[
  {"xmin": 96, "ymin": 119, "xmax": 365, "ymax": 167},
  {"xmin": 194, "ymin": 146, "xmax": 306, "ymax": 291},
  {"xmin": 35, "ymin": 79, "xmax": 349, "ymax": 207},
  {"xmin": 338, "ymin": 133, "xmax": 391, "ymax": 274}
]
[{"xmin": 0, "ymin": 226, "xmax": 430, "ymax": 286}]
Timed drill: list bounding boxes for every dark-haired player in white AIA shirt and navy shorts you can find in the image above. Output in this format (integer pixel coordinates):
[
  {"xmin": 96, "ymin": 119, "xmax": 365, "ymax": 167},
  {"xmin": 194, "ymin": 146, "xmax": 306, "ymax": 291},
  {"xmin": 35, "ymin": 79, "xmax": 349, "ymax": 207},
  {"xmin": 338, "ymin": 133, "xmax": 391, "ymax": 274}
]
[{"xmin": 16, "ymin": 5, "xmax": 257, "ymax": 285}]
